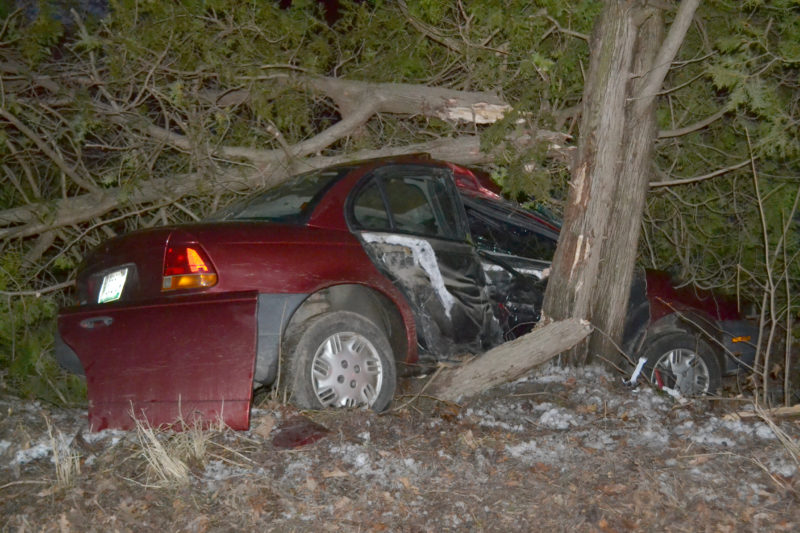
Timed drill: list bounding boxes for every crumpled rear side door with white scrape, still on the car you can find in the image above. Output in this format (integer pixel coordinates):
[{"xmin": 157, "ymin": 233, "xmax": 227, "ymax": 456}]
[{"xmin": 348, "ymin": 164, "xmax": 502, "ymax": 357}]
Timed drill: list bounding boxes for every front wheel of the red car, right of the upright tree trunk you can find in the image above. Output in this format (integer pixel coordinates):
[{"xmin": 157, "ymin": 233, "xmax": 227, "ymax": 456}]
[{"xmin": 641, "ymin": 331, "xmax": 722, "ymax": 396}]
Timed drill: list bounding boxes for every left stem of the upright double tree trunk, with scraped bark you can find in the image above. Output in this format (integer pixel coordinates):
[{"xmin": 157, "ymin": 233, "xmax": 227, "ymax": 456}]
[{"xmin": 543, "ymin": 1, "xmax": 636, "ymax": 364}]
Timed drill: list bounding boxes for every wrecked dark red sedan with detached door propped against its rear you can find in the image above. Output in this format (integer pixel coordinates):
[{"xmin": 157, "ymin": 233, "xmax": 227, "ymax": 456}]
[{"xmin": 56, "ymin": 156, "xmax": 756, "ymax": 430}]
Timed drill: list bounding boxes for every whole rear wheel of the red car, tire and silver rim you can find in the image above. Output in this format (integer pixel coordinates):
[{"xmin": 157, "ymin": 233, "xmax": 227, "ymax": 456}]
[{"xmin": 283, "ymin": 311, "xmax": 397, "ymax": 411}]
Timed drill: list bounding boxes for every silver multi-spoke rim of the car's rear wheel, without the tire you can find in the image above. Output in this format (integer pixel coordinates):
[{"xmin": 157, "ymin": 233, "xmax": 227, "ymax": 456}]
[{"xmin": 311, "ymin": 332, "xmax": 384, "ymax": 407}]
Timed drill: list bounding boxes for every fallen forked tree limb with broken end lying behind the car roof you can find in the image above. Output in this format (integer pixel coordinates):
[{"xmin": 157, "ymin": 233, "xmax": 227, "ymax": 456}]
[{"xmin": 0, "ymin": 65, "xmax": 572, "ymax": 240}]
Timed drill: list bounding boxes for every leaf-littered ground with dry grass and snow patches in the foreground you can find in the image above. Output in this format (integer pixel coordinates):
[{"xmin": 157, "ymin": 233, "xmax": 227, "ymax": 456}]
[{"xmin": 0, "ymin": 367, "xmax": 800, "ymax": 532}]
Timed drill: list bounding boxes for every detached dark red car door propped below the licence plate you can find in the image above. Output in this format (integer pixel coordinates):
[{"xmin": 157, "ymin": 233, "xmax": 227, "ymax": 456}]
[{"xmin": 59, "ymin": 292, "xmax": 258, "ymax": 431}]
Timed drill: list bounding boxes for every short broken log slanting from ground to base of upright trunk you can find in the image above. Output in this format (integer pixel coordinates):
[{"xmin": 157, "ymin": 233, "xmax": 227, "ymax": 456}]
[{"xmin": 428, "ymin": 318, "xmax": 592, "ymax": 402}]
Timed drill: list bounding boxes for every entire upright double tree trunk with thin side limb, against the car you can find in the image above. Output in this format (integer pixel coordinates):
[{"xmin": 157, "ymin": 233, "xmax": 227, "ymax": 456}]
[{"xmin": 544, "ymin": 0, "xmax": 700, "ymax": 364}]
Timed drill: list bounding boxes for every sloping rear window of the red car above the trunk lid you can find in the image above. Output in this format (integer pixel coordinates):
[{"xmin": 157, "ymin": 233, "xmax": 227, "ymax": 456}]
[{"xmin": 208, "ymin": 167, "xmax": 350, "ymax": 224}]
